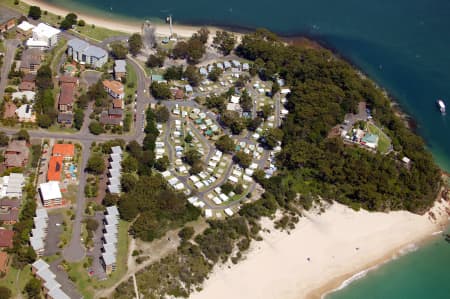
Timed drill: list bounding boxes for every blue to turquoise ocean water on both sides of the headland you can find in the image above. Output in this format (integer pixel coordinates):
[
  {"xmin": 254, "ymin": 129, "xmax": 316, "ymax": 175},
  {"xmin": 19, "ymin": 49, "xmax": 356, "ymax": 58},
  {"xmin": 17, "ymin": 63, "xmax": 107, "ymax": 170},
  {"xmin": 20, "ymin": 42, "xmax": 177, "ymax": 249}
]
[{"xmin": 39, "ymin": 0, "xmax": 450, "ymax": 299}]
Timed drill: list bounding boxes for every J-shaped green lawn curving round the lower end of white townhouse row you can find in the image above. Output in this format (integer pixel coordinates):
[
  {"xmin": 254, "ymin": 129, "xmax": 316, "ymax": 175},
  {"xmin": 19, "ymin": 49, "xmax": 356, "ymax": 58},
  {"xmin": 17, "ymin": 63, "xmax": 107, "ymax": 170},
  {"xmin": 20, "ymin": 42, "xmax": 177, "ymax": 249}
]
[{"xmin": 68, "ymin": 220, "xmax": 130, "ymax": 299}]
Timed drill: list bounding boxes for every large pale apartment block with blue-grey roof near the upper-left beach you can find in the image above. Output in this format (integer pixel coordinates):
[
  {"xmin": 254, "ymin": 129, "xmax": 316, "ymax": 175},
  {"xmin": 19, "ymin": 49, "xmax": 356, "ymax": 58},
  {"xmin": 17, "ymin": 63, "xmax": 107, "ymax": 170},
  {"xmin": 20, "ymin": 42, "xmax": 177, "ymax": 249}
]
[{"xmin": 67, "ymin": 38, "xmax": 108, "ymax": 68}]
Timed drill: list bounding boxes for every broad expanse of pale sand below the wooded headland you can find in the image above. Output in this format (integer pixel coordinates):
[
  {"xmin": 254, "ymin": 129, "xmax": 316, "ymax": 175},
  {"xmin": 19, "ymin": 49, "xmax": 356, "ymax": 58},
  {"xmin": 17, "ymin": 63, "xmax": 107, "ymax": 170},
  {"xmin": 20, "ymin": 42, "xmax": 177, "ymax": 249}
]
[{"xmin": 190, "ymin": 202, "xmax": 449, "ymax": 299}]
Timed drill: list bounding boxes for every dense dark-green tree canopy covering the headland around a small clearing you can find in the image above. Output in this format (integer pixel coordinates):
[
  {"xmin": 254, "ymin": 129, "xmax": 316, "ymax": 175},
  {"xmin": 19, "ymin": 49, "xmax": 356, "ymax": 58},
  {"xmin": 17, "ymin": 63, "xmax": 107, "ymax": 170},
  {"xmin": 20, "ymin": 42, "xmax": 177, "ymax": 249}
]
[{"xmin": 237, "ymin": 30, "xmax": 440, "ymax": 212}]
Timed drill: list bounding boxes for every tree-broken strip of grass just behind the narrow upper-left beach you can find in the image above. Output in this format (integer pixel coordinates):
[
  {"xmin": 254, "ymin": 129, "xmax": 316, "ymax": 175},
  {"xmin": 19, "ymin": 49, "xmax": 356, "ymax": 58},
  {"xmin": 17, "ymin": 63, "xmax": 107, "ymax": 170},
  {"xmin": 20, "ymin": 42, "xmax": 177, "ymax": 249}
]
[{"xmin": 1, "ymin": 0, "xmax": 127, "ymax": 41}]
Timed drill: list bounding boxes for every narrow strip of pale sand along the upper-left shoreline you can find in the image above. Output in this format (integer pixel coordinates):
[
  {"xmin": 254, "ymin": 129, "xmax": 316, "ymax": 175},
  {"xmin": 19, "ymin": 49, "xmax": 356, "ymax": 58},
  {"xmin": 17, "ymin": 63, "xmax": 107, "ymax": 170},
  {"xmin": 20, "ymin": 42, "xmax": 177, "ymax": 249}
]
[{"xmin": 22, "ymin": 0, "xmax": 229, "ymax": 37}]
